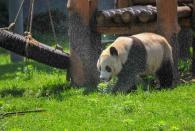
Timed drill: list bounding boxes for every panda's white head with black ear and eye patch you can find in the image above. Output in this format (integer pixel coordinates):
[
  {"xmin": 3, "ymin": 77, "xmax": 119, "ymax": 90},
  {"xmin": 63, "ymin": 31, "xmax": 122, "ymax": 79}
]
[{"xmin": 97, "ymin": 46, "xmax": 122, "ymax": 81}]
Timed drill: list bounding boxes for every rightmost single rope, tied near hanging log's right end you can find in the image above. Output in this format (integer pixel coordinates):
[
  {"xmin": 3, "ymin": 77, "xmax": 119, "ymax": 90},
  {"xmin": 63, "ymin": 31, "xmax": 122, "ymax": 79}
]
[{"xmin": 47, "ymin": 0, "xmax": 63, "ymax": 52}]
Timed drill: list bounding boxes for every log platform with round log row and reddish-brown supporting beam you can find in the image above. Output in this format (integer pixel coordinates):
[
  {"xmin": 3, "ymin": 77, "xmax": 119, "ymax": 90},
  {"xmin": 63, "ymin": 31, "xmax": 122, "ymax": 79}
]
[{"xmin": 96, "ymin": 5, "xmax": 192, "ymax": 34}]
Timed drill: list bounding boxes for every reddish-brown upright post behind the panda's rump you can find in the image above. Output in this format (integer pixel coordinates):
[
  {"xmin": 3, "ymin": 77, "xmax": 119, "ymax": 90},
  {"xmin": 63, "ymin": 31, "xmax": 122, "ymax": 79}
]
[{"xmin": 156, "ymin": 0, "xmax": 180, "ymax": 82}]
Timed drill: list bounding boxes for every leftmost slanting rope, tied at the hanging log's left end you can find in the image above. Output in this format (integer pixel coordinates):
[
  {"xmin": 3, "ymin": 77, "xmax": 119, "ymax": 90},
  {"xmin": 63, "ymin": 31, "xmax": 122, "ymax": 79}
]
[{"xmin": 0, "ymin": 0, "xmax": 24, "ymax": 30}]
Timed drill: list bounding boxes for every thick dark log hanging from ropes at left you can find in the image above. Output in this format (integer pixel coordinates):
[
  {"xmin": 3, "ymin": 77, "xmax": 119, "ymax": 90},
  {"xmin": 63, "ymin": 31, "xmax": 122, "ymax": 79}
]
[{"xmin": 0, "ymin": 29, "xmax": 69, "ymax": 69}]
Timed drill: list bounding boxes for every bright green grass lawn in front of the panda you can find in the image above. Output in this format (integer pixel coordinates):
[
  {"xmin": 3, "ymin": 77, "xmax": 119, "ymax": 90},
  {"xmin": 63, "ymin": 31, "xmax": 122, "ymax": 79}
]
[{"xmin": 0, "ymin": 34, "xmax": 195, "ymax": 131}]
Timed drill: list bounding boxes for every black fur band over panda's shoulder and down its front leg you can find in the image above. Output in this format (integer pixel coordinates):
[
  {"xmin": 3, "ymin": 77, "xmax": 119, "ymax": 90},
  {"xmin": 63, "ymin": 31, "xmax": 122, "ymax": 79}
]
[{"xmin": 113, "ymin": 37, "xmax": 147, "ymax": 92}]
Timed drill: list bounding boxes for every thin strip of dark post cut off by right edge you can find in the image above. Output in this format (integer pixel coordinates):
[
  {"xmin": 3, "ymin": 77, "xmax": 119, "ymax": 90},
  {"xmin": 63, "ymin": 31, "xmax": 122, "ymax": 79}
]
[{"xmin": 192, "ymin": 0, "xmax": 195, "ymax": 77}]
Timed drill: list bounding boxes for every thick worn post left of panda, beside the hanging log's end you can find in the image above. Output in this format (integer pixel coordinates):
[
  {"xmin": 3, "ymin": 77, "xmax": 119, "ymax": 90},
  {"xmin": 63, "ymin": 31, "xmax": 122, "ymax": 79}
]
[{"xmin": 67, "ymin": 0, "xmax": 101, "ymax": 87}]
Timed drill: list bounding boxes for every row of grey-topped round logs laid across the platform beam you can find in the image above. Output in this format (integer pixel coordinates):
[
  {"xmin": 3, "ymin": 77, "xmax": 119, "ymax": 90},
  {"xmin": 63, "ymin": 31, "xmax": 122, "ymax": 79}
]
[{"xmin": 96, "ymin": 5, "xmax": 192, "ymax": 25}]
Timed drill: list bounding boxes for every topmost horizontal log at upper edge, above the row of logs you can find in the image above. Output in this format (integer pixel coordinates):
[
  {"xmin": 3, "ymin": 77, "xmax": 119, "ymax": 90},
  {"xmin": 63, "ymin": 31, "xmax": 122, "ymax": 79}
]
[{"xmin": 132, "ymin": 0, "xmax": 193, "ymax": 5}]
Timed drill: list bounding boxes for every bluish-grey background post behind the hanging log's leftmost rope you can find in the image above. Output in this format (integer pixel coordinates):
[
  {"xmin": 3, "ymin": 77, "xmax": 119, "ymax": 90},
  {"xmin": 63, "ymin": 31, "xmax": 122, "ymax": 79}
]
[{"xmin": 9, "ymin": 0, "xmax": 24, "ymax": 62}]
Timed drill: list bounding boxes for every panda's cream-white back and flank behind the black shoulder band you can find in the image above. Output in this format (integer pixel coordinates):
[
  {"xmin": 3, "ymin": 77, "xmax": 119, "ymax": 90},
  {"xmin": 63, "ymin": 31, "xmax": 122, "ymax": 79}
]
[{"xmin": 132, "ymin": 33, "xmax": 172, "ymax": 74}]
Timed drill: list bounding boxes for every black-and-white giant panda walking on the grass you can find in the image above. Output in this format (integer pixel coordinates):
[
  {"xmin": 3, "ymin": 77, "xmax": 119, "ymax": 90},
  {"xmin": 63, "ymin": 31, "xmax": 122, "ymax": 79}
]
[{"xmin": 97, "ymin": 32, "xmax": 173, "ymax": 92}]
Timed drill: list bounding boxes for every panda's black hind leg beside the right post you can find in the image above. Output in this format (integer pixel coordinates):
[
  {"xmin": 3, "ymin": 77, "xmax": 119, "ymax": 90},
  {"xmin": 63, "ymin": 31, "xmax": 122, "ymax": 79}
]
[{"xmin": 156, "ymin": 60, "xmax": 173, "ymax": 88}]
